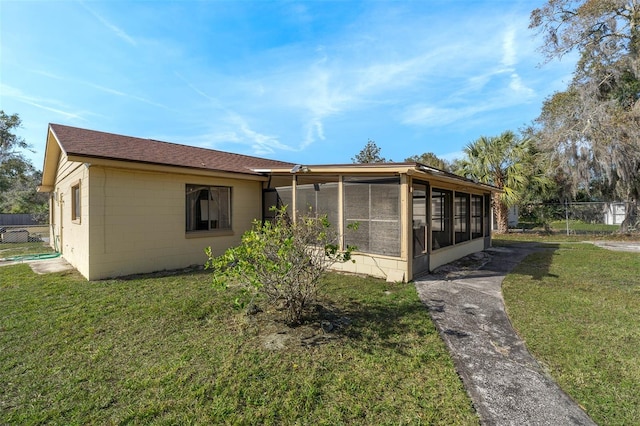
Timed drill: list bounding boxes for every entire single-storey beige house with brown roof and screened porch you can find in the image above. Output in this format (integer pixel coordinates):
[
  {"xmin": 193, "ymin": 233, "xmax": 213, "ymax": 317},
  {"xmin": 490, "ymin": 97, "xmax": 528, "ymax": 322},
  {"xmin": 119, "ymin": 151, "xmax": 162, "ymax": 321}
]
[{"xmin": 39, "ymin": 124, "xmax": 496, "ymax": 281}]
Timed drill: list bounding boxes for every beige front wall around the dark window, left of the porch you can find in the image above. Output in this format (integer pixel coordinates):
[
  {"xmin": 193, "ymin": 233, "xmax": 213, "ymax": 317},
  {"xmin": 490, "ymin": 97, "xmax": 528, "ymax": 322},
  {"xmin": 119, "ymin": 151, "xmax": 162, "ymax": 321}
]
[{"xmin": 85, "ymin": 166, "xmax": 262, "ymax": 279}]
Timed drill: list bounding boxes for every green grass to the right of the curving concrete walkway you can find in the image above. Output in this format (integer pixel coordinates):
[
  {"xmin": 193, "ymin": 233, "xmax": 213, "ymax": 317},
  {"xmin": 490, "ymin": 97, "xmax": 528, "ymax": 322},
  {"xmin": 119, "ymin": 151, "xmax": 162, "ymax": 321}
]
[{"xmin": 497, "ymin": 236, "xmax": 640, "ymax": 425}]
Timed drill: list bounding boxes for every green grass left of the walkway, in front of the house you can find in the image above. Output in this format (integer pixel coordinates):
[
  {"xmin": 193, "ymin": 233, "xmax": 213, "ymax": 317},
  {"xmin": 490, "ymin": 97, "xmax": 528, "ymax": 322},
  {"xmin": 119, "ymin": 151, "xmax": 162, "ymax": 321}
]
[{"xmin": 0, "ymin": 265, "xmax": 478, "ymax": 425}]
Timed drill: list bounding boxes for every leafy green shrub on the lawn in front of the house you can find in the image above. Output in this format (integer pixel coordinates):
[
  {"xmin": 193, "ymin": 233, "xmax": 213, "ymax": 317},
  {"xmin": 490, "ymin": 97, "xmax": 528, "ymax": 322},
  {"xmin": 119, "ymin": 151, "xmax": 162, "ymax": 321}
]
[{"xmin": 205, "ymin": 207, "xmax": 355, "ymax": 325}]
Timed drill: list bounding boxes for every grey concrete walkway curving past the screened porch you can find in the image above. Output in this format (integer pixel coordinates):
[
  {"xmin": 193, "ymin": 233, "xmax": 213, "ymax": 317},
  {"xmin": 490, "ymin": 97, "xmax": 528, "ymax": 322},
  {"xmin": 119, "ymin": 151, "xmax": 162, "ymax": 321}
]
[{"xmin": 415, "ymin": 244, "xmax": 595, "ymax": 425}]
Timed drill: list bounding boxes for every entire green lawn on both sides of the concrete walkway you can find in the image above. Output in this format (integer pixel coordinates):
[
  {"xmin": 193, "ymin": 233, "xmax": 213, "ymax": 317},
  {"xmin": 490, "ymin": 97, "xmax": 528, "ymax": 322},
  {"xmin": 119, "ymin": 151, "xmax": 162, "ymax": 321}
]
[{"xmin": 7, "ymin": 235, "xmax": 640, "ymax": 425}]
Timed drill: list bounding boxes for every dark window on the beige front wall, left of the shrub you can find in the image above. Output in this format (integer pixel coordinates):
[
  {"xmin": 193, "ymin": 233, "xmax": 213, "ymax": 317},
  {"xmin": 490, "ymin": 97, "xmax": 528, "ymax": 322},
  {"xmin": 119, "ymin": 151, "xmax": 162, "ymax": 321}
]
[{"xmin": 186, "ymin": 185, "xmax": 231, "ymax": 232}]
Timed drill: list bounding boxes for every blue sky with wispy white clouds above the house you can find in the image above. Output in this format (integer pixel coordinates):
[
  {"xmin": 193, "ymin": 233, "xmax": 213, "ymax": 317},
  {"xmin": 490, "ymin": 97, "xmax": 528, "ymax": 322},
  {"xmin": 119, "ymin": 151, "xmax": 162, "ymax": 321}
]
[{"xmin": 0, "ymin": 0, "xmax": 574, "ymax": 168}]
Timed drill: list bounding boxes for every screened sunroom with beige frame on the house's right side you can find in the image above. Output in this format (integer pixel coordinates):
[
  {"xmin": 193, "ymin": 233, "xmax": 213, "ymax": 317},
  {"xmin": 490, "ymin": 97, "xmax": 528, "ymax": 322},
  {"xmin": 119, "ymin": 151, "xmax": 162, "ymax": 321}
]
[{"xmin": 263, "ymin": 163, "xmax": 496, "ymax": 281}]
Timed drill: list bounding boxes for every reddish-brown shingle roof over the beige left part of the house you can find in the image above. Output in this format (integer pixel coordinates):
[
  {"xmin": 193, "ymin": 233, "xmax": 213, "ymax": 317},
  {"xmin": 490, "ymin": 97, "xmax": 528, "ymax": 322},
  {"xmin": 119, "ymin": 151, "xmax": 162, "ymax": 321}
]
[{"xmin": 49, "ymin": 124, "xmax": 293, "ymax": 174}]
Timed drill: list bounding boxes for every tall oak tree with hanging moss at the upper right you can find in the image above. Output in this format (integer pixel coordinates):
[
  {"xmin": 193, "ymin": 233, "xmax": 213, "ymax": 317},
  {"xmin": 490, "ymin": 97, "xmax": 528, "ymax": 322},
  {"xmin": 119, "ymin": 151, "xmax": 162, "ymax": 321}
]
[{"xmin": 530, "ymin": 0, "xmax": 640, "ymax": 231}]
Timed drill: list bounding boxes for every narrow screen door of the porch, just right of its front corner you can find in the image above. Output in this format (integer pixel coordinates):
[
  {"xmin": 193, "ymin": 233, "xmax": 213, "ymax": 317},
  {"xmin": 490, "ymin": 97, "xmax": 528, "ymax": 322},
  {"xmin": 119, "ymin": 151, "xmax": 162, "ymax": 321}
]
[{"xmin": 411, "ymin": 182, "xmax": 429, "ymax": 276}]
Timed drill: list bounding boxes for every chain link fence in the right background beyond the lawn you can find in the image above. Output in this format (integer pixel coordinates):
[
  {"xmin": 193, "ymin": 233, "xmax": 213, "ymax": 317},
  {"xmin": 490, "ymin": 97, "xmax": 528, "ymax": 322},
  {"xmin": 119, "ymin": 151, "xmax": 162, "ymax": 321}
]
[{"xmin": 513, "ymin": 202, "xmax": 640, "ymax": 235}]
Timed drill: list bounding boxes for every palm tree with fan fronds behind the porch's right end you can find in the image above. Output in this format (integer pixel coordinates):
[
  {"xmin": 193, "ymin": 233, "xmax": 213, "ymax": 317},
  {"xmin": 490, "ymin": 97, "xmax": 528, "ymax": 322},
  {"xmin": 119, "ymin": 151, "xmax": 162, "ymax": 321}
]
[{"xmin": 457, "ymin": 130, "xmax": 550, "ymax": 234}]
